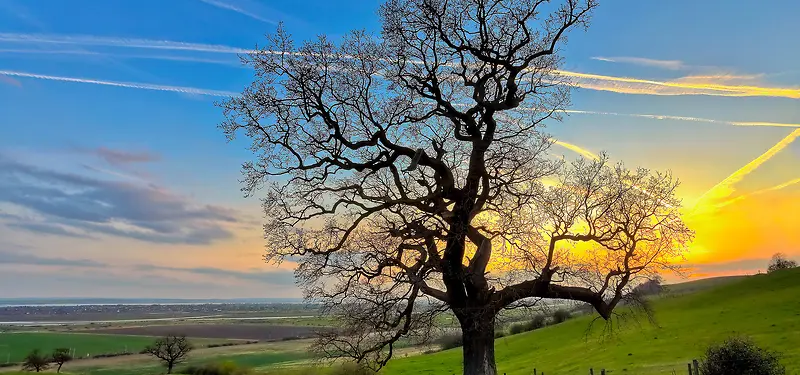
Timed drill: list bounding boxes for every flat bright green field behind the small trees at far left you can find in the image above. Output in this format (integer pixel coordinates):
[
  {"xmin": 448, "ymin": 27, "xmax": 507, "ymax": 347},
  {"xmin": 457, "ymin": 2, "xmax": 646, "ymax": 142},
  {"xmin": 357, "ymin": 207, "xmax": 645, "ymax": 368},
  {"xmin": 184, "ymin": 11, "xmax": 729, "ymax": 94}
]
[{"xmin": 0, "ymin": 332, "xmax": 227, "ymax": 363}]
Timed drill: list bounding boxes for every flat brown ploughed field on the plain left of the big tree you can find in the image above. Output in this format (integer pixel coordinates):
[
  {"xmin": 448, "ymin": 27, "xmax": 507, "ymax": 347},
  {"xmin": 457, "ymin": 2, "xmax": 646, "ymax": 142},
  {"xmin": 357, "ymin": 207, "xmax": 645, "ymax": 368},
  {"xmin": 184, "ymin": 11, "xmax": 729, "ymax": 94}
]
[{"xmin": 74, "ymin": 324, "xmax": 324, "ymax": 341}]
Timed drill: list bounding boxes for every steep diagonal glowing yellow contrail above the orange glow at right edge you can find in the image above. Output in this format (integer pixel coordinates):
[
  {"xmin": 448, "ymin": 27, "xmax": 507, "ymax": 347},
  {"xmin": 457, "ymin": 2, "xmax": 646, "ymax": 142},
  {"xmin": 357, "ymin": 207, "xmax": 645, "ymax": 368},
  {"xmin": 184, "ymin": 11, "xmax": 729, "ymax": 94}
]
[{"xmin": 692, "ymin": 129, "xmax": 800, "ymax": 215}]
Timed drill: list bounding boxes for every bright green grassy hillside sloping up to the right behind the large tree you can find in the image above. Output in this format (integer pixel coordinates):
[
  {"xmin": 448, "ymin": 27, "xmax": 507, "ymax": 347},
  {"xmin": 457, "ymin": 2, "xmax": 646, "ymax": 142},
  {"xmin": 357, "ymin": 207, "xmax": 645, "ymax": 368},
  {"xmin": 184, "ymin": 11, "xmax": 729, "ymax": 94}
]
[{"xmin": 385, "ymin": 269, "xmax": 800, "ymax": 375}]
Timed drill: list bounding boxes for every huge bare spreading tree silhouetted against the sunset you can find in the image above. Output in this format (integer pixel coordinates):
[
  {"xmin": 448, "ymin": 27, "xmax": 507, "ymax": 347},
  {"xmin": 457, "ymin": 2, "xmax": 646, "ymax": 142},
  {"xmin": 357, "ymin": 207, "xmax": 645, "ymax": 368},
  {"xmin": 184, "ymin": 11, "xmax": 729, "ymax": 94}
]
[{"xmin": 220, "ymin": 0, "xmax": 692, "ymax": 375}]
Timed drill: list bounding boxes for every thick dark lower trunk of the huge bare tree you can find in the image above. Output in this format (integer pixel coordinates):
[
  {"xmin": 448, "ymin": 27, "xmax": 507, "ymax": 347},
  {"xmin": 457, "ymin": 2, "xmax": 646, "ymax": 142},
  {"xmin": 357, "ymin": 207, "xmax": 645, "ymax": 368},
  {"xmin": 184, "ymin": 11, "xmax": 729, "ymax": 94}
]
[{"xmin": 461, "ymin": 319, "xmax": 497, "ymax": 375}]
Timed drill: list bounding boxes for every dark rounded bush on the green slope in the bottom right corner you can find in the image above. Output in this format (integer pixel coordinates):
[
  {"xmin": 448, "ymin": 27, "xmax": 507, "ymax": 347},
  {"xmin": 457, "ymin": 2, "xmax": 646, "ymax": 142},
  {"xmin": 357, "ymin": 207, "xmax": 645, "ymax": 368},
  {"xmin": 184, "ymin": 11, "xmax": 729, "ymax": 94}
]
[{"xmin": 700, "ymin": 336, "xmax": 786, "ymax": 375}]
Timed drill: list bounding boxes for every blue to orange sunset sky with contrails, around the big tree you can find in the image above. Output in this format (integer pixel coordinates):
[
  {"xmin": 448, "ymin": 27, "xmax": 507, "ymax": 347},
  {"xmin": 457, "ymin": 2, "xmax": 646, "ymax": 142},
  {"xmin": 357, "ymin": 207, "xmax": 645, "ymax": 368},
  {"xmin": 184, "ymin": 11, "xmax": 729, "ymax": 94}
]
[{"xmin": 0, "ymin": 0, "xmax": 800, "ymax": 298}]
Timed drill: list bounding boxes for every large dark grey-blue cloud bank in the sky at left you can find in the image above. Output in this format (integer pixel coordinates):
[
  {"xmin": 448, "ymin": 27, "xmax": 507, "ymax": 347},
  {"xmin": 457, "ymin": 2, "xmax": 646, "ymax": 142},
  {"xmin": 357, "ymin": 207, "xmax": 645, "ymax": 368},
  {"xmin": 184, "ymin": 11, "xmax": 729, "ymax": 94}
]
[{"xmin": 0, "ymin": 155, "xmax": 239, "ymax": 245}]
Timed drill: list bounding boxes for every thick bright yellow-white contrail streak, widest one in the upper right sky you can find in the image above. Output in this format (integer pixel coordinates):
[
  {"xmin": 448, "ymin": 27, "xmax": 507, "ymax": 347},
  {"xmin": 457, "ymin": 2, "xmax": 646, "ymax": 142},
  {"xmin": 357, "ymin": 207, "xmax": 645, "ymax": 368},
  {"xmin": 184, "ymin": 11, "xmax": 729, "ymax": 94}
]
[{"xmin": 557, "ymin": 70, "xmax": 800, "ymax": 99}]
